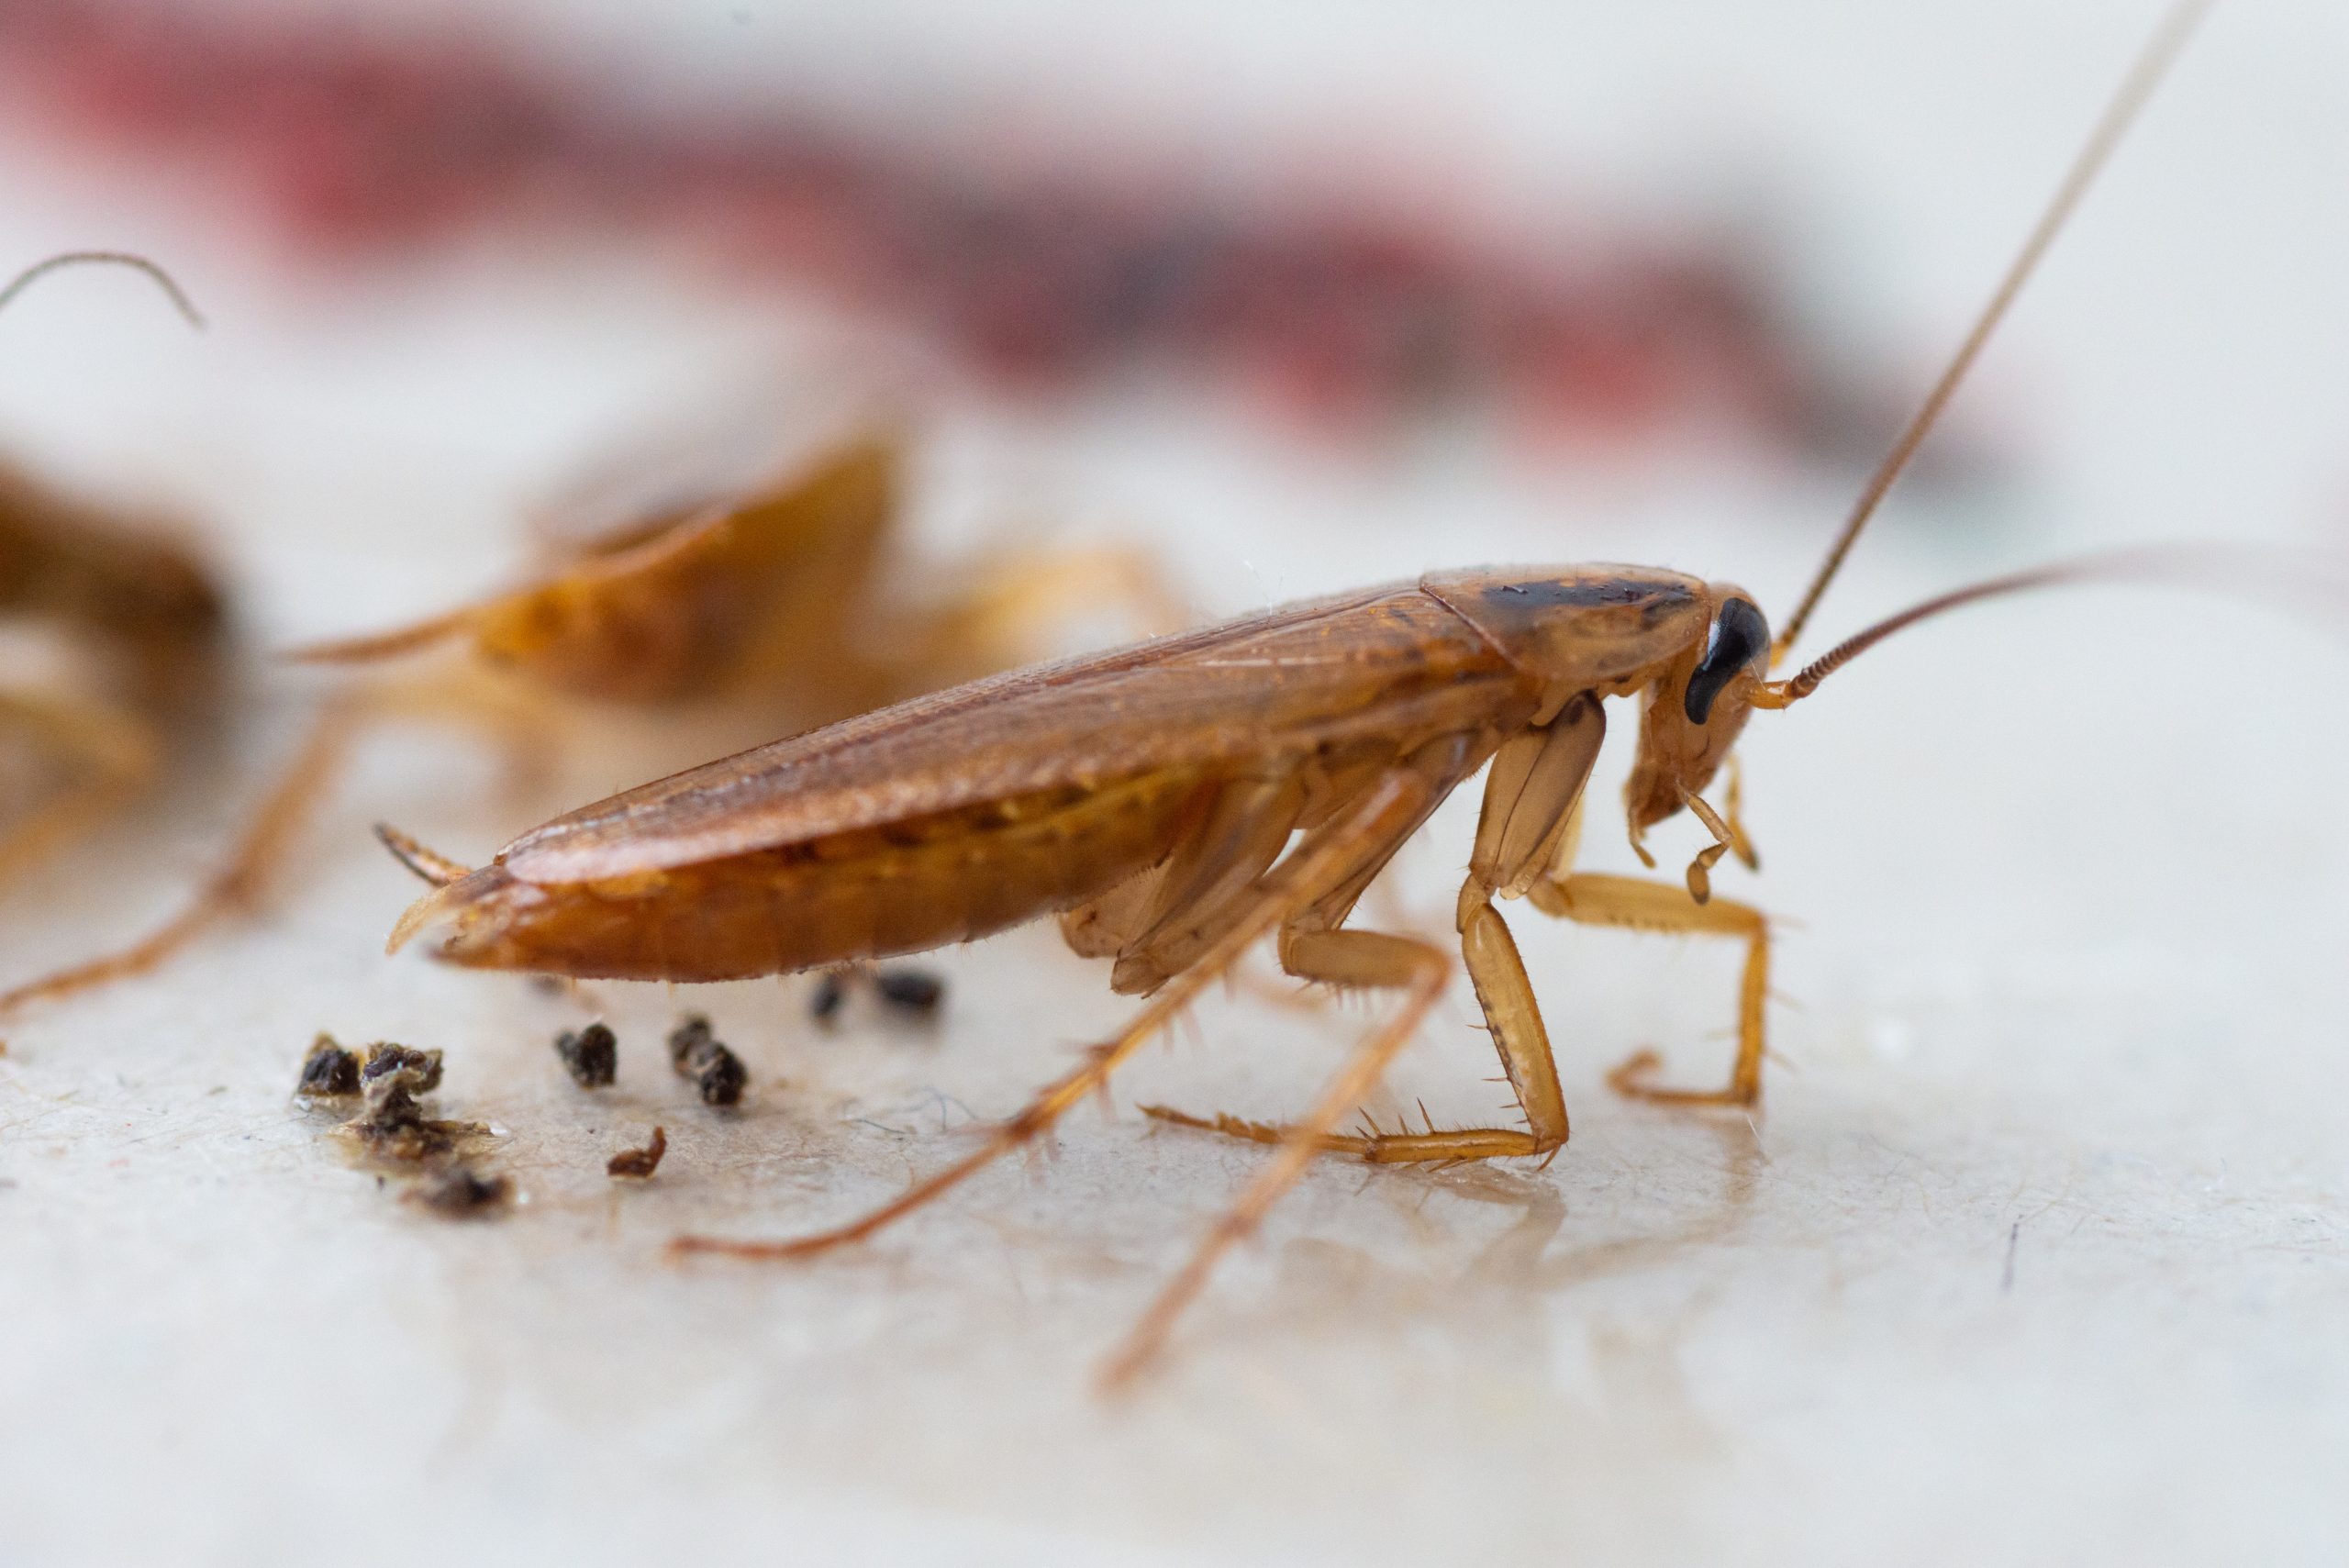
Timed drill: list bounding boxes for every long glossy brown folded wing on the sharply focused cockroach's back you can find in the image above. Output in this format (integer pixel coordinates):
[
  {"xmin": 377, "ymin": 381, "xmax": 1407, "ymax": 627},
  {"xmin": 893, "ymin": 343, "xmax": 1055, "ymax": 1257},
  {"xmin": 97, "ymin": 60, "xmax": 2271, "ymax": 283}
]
[{"xmin": 498, "ymin": 584, "xmax": 1534, "ymax": 883}]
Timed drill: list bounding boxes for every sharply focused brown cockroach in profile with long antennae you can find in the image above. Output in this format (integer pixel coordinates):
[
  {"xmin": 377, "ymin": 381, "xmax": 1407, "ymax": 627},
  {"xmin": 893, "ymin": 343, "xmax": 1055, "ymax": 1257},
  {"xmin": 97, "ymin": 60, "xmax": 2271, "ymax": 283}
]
[{"xmin": 375, "ymin": 0, "xmax": 2201, "ymax": 1383}]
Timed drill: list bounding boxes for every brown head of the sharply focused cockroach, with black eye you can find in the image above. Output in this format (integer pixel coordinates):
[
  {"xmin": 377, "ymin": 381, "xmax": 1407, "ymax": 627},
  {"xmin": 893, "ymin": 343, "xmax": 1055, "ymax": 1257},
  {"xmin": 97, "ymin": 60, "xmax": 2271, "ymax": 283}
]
[{"xmin": 1623, "ymin": 582, "xmax": 1769, "ymax": 833}]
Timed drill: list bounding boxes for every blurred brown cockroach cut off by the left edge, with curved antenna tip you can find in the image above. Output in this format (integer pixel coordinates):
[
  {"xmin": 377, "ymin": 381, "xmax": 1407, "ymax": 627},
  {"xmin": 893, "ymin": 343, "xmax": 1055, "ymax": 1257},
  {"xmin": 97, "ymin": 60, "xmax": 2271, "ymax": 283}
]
[{"xmin": 0, "ymin": 251, "xmax": 228, "ymax": 878}]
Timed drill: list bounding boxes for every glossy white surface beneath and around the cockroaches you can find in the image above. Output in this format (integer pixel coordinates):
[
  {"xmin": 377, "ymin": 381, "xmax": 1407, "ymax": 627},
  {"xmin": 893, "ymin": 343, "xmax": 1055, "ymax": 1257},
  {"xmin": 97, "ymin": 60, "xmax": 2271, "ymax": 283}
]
[{"xmin": 0, "ymin": 3, "xmax": 2349, "ymax": 1563}]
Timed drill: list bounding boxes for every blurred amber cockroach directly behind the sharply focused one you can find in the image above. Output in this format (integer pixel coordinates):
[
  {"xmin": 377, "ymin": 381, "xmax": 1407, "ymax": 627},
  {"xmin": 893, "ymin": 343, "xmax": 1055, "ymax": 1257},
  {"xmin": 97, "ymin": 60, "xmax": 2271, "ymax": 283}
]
[{"xmin": 0, "ymin": 394, "xmax": 1182, "ymax": 1017}]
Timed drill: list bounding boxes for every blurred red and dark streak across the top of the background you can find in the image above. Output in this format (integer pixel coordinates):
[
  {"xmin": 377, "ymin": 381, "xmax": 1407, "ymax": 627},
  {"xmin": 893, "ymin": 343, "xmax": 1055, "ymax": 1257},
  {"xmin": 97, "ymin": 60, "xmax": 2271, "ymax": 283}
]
[{"xmin": 0, "ymin": 0, "xmax": 1935, "ymax": 460}]
